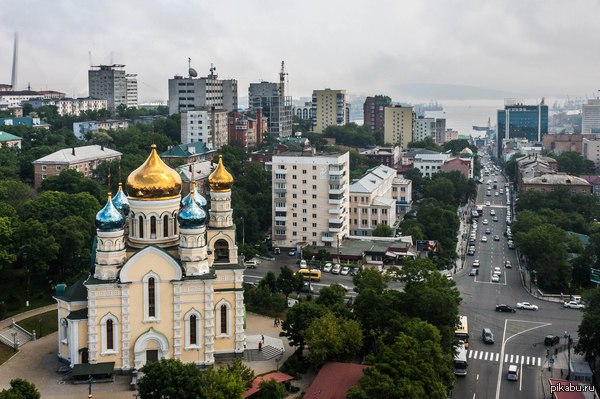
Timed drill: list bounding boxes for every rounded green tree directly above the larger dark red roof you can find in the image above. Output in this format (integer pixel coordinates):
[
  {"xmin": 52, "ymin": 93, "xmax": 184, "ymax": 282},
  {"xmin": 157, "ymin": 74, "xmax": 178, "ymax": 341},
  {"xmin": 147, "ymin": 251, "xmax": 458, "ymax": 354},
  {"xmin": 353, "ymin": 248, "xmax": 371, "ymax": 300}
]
[{"xmin": 305, "ymin": 313, "xmax": 362, "ymax": 365}]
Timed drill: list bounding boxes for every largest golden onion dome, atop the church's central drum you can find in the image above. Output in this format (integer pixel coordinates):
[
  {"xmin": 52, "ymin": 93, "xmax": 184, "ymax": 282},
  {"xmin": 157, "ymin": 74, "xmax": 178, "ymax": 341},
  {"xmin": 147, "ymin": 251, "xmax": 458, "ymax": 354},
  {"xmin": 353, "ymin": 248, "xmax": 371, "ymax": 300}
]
[{"xmin": 127, "ymin": 144, "xmax": 181, "ymax": 200}]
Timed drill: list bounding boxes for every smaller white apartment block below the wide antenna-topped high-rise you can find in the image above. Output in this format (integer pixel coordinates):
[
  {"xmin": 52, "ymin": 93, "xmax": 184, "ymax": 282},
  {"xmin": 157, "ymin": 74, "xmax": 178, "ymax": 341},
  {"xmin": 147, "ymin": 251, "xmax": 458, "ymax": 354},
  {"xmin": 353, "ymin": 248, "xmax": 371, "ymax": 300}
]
[{"xmin": 181, "ymin": 107, "xmax": 228, "ymax": 150}]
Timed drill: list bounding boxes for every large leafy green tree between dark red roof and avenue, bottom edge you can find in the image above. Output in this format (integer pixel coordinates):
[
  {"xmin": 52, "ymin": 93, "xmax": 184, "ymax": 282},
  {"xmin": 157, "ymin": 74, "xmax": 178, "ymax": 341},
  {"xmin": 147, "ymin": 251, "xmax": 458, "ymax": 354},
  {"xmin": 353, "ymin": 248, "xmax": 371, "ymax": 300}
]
[{"xmin": 347, "ymin": 319, "xmax": 454, "ymax": 399}]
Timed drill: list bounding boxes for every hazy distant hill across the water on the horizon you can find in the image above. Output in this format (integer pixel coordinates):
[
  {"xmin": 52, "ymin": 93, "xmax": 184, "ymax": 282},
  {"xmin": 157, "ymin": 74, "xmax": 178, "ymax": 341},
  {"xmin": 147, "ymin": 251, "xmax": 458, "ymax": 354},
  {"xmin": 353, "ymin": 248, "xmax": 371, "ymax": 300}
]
[{"xmin": 394, "ymin": 83, "xmax": 523, "ymax": 100}]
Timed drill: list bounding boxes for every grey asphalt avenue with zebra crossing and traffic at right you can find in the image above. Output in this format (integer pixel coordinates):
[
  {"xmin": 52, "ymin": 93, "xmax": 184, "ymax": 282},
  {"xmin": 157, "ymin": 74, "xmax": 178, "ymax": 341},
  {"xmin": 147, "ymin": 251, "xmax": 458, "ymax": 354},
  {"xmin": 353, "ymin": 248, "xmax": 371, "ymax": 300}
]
[{"xmin": 453, "ymin": 160, "xmax": 582, "ymax": 399}]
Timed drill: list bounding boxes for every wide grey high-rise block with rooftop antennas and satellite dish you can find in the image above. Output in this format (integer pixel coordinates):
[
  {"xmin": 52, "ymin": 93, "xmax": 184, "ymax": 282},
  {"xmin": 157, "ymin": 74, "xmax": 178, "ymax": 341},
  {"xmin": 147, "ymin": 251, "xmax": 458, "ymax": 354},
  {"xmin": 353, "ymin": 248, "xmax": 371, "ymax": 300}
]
[{"xmin": 169, "ymin": 67, "xmax": 238, "ymax": 114}]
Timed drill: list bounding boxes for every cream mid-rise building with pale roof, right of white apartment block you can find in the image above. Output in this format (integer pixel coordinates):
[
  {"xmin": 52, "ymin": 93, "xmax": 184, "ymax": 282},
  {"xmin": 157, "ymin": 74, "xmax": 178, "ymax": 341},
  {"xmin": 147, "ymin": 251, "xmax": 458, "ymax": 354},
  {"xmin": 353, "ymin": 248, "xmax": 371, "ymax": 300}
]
[{"xmin": 350, "ymin": 165, "xmax": 412, "ymax": 236}]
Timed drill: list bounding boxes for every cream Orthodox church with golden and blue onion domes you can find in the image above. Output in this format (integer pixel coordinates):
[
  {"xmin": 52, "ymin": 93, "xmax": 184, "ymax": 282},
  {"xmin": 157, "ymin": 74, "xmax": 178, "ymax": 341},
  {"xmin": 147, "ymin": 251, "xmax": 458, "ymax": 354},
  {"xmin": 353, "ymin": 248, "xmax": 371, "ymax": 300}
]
[{"xmin": 55, "ymin": 145, "xmax": 245, "ymax": 371}]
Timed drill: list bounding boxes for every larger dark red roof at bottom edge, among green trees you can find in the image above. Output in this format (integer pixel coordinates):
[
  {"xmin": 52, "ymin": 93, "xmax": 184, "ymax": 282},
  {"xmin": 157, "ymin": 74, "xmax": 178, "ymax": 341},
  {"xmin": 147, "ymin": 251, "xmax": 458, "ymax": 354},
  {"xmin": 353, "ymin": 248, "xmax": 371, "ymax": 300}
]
[{"xmin": 304, "ymin": 363, "xmax": 367, "ymax": 399}]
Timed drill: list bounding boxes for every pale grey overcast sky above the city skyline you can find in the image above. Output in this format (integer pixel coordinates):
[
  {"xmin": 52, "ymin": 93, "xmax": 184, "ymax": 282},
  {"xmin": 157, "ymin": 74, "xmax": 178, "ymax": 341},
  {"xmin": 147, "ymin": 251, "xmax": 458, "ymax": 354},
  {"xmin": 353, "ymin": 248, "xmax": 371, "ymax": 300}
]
[{"xmin": 0, "ymin": 0, "xmax": 600, "ymax": 105}]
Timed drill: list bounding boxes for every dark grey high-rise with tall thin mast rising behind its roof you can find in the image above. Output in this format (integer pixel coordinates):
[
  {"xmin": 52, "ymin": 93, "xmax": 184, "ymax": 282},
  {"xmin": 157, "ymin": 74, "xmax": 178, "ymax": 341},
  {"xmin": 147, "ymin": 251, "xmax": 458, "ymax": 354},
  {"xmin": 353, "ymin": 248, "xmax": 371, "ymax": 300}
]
[{"xmin": 248, "ymin": 82, "xmax": 293, "ymax": 137}]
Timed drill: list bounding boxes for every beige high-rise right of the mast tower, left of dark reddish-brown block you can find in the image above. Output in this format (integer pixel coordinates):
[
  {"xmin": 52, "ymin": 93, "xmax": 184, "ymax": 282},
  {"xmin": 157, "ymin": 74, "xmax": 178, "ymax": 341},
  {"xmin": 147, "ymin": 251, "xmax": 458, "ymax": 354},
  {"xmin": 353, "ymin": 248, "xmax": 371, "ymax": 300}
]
[{"xmin": 312, "ymin": 89, "xmax": 349, "ymax": 133}]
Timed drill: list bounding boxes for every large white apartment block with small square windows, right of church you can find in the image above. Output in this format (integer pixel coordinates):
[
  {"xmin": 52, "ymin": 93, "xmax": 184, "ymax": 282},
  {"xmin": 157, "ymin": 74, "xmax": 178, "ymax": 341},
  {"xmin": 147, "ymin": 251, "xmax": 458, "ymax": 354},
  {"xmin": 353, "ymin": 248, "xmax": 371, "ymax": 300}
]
[{"xmin": 271, "ymin": 150, "xmax": 350, "ymax": 248}]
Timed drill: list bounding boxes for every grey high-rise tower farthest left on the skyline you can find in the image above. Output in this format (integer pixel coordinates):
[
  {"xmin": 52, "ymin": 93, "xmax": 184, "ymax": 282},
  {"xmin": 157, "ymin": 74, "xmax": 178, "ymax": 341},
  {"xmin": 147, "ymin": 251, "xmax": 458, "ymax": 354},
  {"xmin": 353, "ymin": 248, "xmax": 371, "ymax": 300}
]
[{"xmin": 88, "ymin": 64, "xmax": 131, "ymax": 113}]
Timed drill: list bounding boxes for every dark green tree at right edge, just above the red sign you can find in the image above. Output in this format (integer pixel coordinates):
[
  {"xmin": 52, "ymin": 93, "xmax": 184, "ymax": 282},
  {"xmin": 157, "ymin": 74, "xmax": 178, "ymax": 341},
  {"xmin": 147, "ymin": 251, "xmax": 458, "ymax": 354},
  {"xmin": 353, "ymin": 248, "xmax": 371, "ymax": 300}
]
[{"xmin": 575, "ymin": 288, "xmax": 600, "ymax": 359}]
